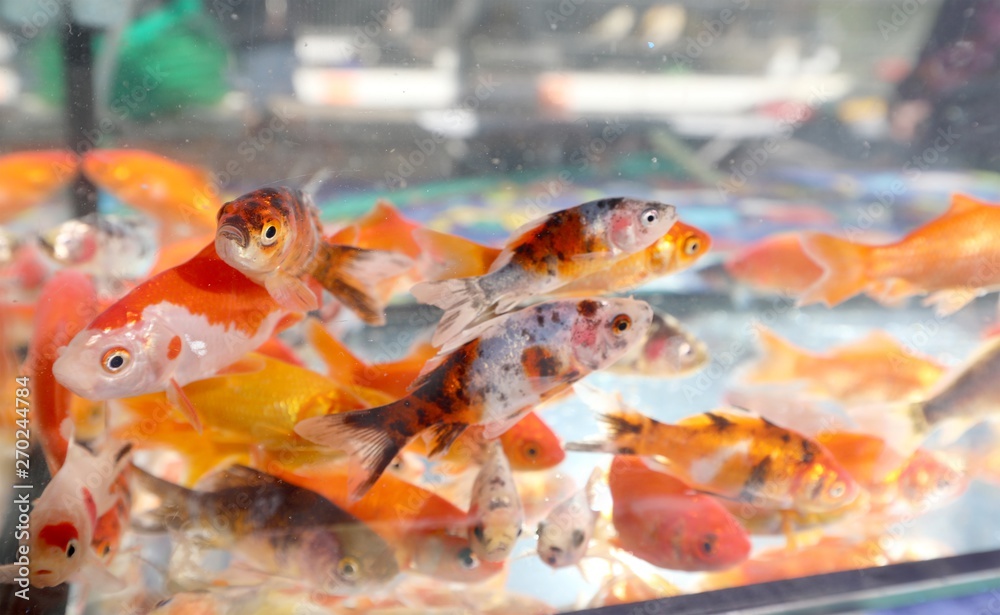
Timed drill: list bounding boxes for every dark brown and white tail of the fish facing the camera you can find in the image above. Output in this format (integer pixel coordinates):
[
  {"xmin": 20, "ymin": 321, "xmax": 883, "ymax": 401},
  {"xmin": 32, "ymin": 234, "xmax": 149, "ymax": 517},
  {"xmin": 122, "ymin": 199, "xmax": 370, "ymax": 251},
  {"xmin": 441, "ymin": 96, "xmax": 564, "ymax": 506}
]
[{"xmin": 310, "ymin": 242, "xmax": 413, "ymax": 325}]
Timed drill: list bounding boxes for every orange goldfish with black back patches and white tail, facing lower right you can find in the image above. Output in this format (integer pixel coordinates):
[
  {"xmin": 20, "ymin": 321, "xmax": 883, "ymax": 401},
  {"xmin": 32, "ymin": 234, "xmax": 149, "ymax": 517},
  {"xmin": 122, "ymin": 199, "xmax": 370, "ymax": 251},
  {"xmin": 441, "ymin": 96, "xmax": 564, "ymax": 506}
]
[{"xmin": 566, "ymin": 389, "xmax": 860, "ymax": 512}]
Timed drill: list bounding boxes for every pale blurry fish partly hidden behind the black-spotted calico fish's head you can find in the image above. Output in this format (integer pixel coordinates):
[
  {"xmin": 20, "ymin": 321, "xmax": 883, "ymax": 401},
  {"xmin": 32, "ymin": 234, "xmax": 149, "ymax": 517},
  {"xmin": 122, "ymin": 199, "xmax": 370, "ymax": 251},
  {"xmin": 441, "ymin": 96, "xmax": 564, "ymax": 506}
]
[{"xmin": 608, "ymin": 312, "xmax": 709, "ymax": 378}]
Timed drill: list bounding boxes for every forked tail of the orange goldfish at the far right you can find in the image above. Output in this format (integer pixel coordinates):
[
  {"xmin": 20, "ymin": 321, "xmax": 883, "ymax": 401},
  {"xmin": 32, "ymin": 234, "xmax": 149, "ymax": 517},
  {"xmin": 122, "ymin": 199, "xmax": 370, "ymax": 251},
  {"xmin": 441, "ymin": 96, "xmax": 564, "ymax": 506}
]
[{"xmin": 799, "ymin": 233, "xmax": 872, "ymax": 307}]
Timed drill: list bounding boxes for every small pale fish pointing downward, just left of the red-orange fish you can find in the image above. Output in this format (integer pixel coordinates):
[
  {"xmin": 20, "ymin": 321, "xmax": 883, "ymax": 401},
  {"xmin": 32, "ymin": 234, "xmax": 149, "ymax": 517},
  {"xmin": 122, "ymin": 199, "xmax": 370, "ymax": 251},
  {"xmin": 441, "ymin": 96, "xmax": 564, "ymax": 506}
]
[{"xmin": 538, "ymin": 468, "xmax": 603, "ymax": 568}]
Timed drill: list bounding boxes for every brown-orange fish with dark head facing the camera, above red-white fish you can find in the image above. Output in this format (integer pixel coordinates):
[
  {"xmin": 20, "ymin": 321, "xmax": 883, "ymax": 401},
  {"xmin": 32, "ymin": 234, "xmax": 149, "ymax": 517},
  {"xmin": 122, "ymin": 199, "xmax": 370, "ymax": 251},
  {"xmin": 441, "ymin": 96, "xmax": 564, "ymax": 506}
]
[{"xmin": 215, "ymin": 188, "xmax": 412, "ymax": 324}]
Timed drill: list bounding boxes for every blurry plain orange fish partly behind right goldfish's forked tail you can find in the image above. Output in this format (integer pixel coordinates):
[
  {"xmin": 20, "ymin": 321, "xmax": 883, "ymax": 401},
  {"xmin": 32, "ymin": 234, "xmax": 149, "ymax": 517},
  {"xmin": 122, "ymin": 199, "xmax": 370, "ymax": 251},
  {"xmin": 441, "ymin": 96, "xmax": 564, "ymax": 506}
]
[{"xmin": 726, "ymin": 232, "xmax": 823, "ymax": 297}]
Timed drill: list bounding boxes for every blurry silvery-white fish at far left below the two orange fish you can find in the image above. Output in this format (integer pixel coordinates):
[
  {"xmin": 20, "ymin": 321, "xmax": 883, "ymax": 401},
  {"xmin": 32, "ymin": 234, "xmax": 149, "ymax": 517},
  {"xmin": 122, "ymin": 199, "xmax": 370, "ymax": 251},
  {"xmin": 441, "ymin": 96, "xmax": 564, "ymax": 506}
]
[{"xmin": 38, "ymin": 214, "xmax": 159, "ymax": 288}]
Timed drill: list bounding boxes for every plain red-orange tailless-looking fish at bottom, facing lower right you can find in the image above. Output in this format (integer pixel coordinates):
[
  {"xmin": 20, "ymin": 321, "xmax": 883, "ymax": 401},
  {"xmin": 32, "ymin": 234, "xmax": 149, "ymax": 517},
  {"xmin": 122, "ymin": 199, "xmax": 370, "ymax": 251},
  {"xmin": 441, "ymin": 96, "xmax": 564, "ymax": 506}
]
[{"xmin": 608, "ymin": 455, "xmax": 750, "ymax": 571}]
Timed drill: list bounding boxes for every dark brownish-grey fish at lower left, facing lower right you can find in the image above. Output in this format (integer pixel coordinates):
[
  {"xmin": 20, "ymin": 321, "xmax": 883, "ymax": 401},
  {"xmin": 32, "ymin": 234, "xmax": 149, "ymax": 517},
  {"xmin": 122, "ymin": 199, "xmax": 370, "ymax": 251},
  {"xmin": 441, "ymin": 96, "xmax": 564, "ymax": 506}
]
[{"xmin": 134, "ymin": 466, "xmax": 398, "ymax": 593}]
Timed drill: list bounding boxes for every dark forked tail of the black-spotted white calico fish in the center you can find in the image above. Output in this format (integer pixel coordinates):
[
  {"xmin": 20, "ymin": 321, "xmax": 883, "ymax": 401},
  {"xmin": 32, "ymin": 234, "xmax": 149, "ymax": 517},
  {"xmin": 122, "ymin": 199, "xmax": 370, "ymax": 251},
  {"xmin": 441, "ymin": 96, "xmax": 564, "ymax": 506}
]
[{"xmin": 295, "ymin": 398, "xmax": 421, "ymax": 501}]
